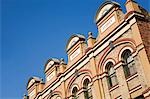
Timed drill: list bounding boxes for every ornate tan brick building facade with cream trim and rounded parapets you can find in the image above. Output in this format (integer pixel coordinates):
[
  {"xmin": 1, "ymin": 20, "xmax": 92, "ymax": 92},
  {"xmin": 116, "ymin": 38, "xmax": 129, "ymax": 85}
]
[{"xmin": 24, "ymin": 0, "xmax": 150, "ymax": 99}]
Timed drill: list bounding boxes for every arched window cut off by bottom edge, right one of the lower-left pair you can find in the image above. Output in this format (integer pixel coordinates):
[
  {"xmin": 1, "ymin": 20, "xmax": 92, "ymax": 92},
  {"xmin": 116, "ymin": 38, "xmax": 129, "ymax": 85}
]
[{"xmin": 83, "ymin": 78, "xmax": 92, "ymax": 99}]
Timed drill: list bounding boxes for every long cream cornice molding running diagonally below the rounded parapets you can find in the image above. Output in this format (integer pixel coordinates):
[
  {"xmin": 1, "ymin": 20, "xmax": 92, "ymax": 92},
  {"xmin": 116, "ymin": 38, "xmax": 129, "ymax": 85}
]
[{"xmin": 41, "ymin": 11, "xmax": 139, "ymax": 98}]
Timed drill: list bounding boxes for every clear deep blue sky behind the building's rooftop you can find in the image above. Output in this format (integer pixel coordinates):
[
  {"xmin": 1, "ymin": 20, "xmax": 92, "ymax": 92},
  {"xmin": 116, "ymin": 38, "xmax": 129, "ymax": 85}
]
[{"xmin": 0, "ymin": 0, "xmax": 150, "ymax": 99}]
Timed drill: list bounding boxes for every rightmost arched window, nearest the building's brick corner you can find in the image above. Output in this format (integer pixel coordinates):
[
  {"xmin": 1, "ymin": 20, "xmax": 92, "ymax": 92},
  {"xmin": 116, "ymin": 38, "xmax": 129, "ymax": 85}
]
[{"xmin": 121, "ymin": 49, "xmax": 136, "ymax": 78}]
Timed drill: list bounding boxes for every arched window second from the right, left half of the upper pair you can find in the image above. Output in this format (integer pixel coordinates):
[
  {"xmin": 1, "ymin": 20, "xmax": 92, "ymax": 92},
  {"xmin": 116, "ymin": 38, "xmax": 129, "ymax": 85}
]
[{"xmin": 106, "ymin": 62, "xmax": 118, "ymax": 88}]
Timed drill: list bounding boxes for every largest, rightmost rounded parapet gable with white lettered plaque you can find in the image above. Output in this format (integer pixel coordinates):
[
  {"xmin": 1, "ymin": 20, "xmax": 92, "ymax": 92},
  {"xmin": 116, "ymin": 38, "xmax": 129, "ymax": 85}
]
[{"xmin": 95, "ymin": 1, "xmax": 124, "ymax": 41}]
